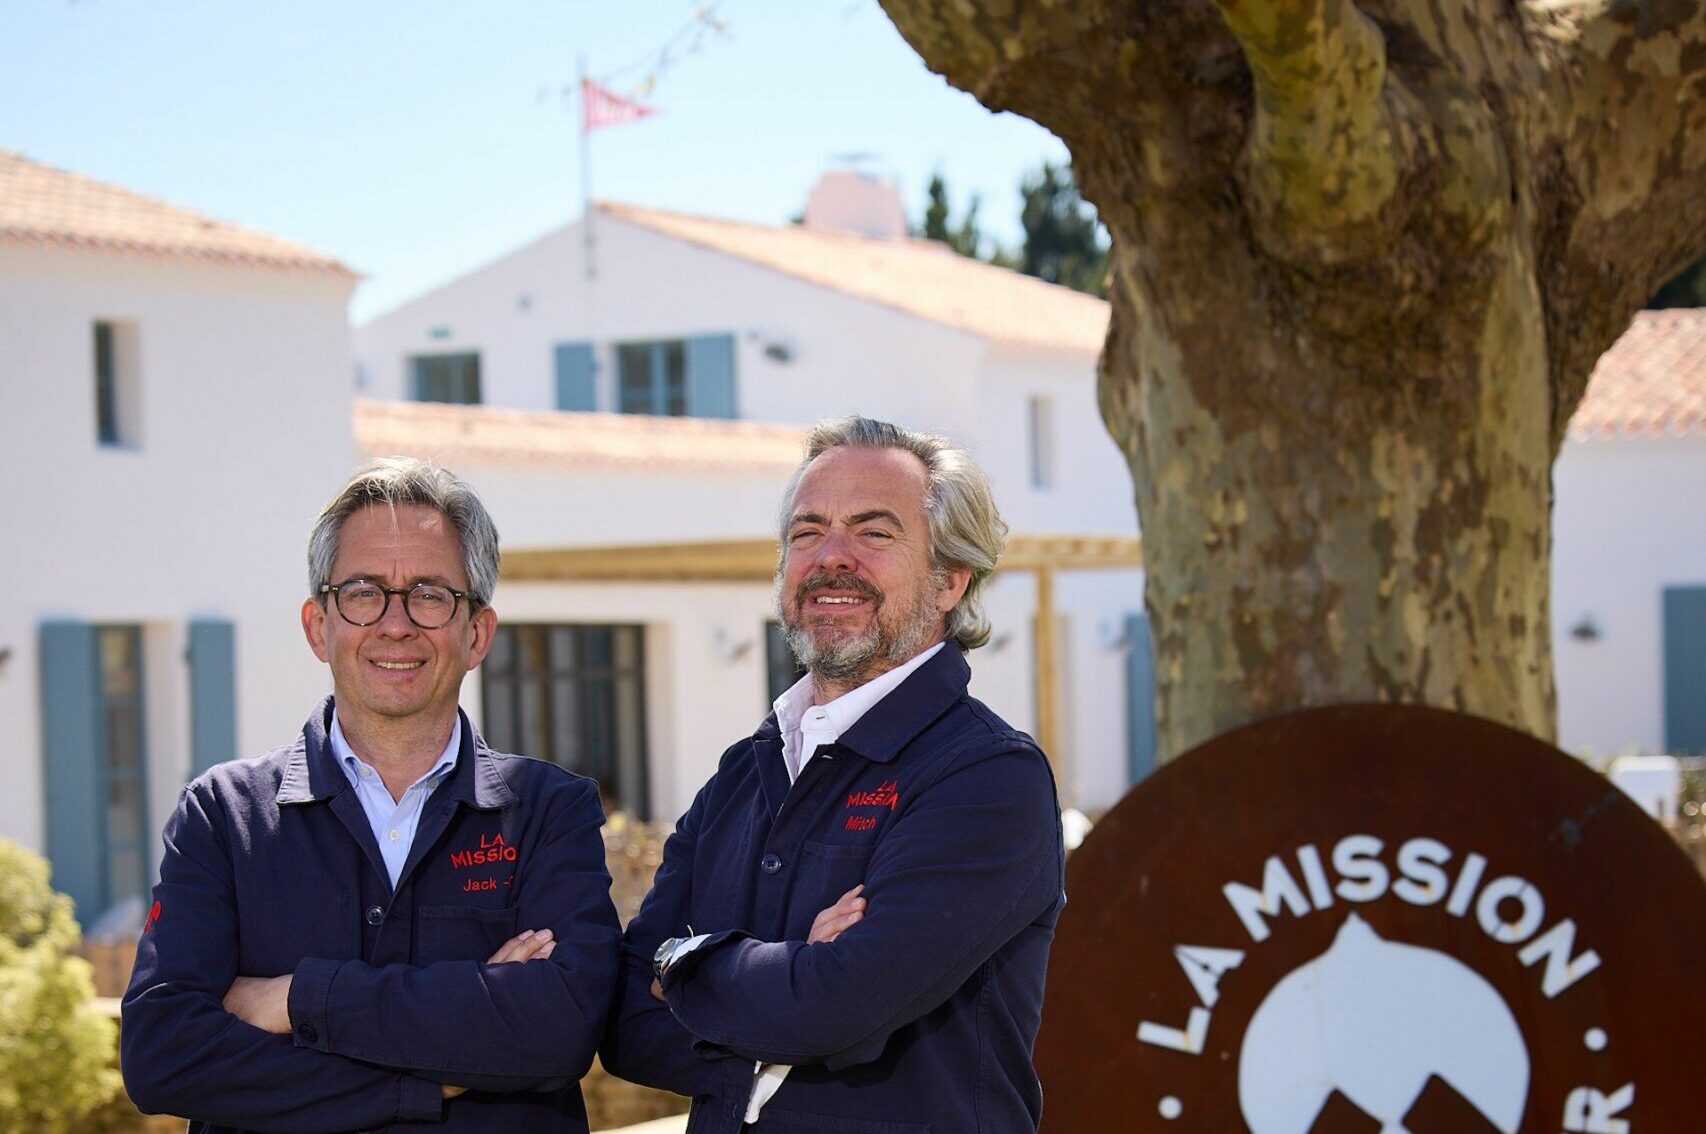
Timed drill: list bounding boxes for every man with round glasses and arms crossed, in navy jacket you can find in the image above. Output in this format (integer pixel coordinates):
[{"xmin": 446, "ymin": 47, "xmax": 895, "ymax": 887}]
[{"xmin": 123, "ymin": 459, "xmax": 619, "ymax": 1134}]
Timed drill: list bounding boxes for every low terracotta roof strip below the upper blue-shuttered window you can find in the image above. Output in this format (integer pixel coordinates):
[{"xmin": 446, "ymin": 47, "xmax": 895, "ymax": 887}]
[{"xmin": 355, "ymin": 401, "xmax": 807, "ymax": 477}]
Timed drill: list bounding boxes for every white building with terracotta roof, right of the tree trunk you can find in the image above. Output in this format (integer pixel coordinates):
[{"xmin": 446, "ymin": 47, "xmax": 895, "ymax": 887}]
[{"xmin": 1552, "ymin": 309, "xmax": 1706, "ymax": 757}]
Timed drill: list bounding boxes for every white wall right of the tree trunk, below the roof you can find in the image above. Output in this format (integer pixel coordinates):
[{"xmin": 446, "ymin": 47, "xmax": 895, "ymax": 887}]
[{"xmin": 1552, "ymin": 437, "xmax": 1706, "ymax": 755}]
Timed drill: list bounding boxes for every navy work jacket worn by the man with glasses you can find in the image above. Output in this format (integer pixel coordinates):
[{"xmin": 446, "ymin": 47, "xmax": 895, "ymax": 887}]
[{"xmin": 121, "ymin": 697, "xmax": 621, "ymax": 1134}]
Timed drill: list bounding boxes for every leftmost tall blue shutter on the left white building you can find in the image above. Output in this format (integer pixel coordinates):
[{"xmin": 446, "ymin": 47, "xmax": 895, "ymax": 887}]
[{"xmin": 39, "ymin": 621, "xmax": 106, "ymax": 924}]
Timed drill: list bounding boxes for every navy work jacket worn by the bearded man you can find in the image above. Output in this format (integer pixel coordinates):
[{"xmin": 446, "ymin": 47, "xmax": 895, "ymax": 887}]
[{"xmin": 602, "ymin": 645, "xmax": 1065, "ymax": 1134}]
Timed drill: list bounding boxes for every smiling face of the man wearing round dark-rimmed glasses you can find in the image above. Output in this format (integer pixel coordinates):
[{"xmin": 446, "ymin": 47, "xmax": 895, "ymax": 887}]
[{"xmin": 302, "ymin": 505, "xmax": 496, "ymax": 743}]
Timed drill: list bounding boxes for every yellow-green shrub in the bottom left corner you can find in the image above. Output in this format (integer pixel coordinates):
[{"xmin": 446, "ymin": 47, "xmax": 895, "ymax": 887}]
[{"xmin": 0, "ymin": 839, "xmax": 119, "ymax": 1134}]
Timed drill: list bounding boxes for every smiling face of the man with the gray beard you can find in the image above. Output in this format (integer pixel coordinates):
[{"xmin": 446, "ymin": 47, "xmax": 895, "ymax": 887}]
[{"xmin": 776, "ymin": 447, "xmax": 971, "ymax": 699}]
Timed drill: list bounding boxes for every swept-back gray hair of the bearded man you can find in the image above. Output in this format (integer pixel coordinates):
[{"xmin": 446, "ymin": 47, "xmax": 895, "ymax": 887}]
[{"xmin": 780, "ymin": 416, "xmax": 1007, "ymax": 650}]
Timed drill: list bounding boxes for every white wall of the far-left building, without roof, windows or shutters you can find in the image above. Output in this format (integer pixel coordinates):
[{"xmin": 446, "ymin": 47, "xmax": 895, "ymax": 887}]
[{"xmin": 0, "ymin": 247, "xmax": 355, "ymax": 851}]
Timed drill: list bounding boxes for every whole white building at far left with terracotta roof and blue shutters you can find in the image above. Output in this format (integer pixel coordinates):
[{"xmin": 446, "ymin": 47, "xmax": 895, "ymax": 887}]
[{"xmin": 0, "ymin": 150, "xmax": 355, "ymax": 917}]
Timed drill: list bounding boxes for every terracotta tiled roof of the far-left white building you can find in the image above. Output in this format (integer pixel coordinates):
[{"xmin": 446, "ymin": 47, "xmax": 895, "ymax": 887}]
[{"xmin": 0, "ymin": 150, "xmax": 355, "ymax": 276}]
